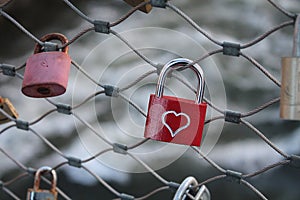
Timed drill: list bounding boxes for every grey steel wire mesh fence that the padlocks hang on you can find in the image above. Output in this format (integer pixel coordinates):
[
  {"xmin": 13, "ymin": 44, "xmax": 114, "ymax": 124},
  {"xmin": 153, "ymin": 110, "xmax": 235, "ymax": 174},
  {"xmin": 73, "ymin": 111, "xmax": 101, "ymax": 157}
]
[{"xmin": 0, "ymin": 0, "xmax": 300, "ymax": 199}]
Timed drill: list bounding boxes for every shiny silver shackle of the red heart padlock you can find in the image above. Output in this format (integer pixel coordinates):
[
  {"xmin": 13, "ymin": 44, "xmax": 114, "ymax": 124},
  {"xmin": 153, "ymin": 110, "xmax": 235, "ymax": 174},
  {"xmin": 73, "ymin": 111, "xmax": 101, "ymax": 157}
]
[{"xmin": 155, "ymin": 58, "xmax": 205, "ymax": 104}]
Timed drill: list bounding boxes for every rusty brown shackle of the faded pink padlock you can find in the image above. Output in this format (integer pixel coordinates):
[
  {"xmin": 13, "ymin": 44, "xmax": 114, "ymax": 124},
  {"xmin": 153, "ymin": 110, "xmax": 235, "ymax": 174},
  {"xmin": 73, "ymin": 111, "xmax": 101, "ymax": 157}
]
[{"xmin": 34, "ymin": 33, "xmax": 69, "ymax": 54}]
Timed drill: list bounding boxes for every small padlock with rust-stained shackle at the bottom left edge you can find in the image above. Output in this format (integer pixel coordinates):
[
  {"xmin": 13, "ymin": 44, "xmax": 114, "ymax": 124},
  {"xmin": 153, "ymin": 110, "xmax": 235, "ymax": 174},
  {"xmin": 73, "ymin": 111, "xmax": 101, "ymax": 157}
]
[{"xmin": 27, "ymin": 167, "xmax": 57, "ymax": 200}]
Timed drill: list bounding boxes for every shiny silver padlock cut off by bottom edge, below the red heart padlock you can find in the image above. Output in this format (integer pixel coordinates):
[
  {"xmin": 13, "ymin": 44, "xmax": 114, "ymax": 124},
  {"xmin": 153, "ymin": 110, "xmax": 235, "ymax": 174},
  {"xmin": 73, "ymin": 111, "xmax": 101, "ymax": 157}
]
[{"xmin": 173, "ymin": 176, "xmax": 211, "ymax": 200}]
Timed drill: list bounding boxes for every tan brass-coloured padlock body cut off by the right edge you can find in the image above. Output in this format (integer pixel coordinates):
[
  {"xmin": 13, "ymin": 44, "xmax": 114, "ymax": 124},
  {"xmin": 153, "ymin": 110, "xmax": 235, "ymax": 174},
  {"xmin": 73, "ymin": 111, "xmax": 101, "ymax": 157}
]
[{"xmin": 280, "ymin": 57, "xmax": 300, "ymax": 120}]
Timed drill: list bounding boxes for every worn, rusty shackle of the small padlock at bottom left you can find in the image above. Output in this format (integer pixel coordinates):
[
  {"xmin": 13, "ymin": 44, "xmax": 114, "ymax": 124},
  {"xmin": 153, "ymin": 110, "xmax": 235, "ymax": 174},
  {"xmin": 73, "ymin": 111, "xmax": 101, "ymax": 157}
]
[{"xmin": 33, "ymin": 166, "xmax": 57, "ymax": 193}]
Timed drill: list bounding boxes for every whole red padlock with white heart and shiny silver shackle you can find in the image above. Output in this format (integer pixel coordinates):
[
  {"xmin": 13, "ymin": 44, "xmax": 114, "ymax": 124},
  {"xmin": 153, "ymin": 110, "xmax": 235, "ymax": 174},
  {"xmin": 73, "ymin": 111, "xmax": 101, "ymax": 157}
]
[{"xmin": 144, "ymin": 58, "xmax": 207, "ymax": 146}]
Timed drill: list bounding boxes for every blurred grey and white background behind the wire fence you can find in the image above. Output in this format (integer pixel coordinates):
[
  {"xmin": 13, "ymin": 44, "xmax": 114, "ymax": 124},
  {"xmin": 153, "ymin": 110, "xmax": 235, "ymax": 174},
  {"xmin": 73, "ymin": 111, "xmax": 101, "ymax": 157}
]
[{"xmin": 0, "ymin": 0, "xmax": 300, "ymax": 200}]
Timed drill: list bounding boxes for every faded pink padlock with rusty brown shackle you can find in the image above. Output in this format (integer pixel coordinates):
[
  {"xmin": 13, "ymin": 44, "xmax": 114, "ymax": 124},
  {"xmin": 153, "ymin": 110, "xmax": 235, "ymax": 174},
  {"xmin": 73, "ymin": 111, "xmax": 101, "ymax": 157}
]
[{"xmin": 22, "ymin": 33, "xmax": 71, "ymax": 98}]
